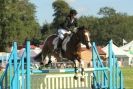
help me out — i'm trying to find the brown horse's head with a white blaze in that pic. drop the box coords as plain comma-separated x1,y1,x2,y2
76,27,91,49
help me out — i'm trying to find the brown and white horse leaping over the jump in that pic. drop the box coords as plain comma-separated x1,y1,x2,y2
35,27,91,81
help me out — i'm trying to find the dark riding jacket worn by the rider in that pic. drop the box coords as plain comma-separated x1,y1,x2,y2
62,15,78,30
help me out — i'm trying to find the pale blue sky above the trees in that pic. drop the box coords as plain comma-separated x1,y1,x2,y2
30,0,133,26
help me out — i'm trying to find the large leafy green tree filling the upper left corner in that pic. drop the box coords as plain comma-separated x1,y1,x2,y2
0,0,40,50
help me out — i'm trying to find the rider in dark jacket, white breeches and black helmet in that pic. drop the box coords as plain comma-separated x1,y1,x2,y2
56,9,78,52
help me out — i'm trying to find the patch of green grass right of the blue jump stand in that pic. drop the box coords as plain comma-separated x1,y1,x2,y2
121,67,133,89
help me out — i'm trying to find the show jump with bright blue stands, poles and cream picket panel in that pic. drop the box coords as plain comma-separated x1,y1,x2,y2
0,41,124,89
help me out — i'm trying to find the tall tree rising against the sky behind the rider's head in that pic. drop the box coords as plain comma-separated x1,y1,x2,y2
52,0,70,28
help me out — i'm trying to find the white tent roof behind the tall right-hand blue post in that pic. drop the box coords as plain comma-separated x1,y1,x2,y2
102,44,130,57
